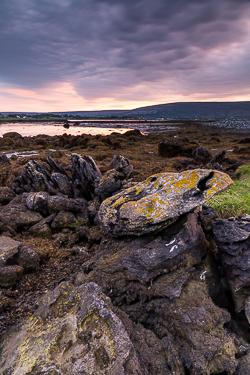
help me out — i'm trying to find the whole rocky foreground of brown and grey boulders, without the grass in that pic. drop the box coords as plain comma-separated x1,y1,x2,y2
0,128,250,375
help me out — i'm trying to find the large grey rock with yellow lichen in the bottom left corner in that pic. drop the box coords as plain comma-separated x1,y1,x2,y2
0,283,145,375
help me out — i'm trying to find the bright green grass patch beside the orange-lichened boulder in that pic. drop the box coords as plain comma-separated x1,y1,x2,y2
208,165,250,218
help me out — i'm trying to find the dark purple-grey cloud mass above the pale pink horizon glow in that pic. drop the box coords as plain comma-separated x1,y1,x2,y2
0,0,250,97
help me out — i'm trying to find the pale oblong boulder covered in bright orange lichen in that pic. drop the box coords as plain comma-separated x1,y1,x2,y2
99,169,233,236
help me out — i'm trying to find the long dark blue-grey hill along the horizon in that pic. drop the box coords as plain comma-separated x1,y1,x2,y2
2,102,250,120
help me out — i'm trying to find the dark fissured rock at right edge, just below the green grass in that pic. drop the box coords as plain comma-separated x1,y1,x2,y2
212,215,250,316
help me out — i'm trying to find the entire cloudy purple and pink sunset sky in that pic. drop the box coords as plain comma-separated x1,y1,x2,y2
0,0,250,112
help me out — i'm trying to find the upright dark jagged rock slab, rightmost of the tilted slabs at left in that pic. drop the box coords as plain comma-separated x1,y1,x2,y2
72,154,102,200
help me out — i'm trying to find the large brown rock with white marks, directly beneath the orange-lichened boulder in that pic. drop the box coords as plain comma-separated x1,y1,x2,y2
77,213,237,375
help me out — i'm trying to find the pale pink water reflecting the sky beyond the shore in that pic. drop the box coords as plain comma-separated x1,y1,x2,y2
0,123,135,137
